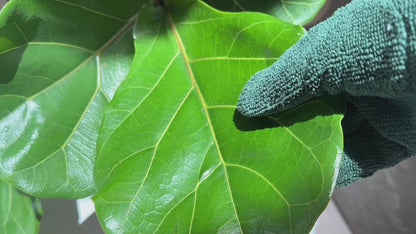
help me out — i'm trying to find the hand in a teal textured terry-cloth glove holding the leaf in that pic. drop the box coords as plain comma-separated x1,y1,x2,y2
237,0,416,187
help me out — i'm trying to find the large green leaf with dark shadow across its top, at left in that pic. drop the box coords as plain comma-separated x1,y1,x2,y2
0,0,141,198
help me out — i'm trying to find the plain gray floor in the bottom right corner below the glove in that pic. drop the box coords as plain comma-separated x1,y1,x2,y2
333,157,416,234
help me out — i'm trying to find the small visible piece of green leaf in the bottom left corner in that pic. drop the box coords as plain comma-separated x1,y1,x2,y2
0,180,40,234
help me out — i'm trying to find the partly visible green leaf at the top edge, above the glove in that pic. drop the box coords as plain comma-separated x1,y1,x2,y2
204,0,326,25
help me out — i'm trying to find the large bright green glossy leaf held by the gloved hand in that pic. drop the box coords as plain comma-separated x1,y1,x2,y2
93,2,342,233
